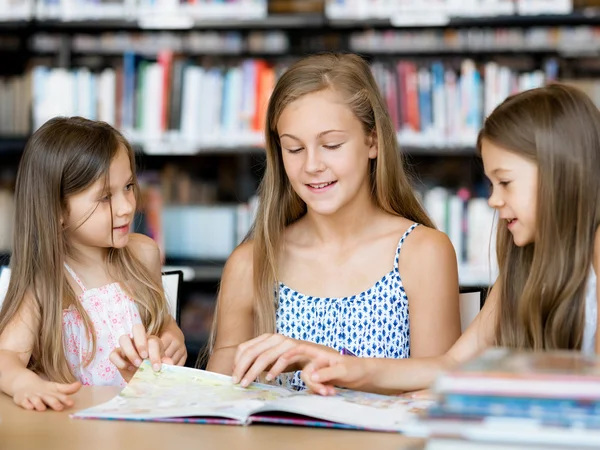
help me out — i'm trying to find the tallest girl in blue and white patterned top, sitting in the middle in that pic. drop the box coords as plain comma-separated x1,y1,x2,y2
208,54,460,389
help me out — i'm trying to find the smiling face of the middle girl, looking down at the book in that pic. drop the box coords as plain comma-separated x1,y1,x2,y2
277,89,377,215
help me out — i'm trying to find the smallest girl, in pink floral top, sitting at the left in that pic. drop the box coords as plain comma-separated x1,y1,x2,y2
0,117,186,411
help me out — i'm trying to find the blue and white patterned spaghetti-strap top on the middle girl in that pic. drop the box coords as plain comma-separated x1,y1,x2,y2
276,223,418,390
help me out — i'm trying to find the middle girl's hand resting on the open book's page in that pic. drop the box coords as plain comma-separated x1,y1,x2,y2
231,333,337,387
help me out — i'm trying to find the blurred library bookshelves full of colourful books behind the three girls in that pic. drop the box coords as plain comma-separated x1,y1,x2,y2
0,0,600,362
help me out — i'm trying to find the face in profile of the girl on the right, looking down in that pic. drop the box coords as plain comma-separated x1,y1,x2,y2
481,139,538,247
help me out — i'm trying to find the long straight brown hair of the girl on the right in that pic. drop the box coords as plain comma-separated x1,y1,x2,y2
477,84,600,349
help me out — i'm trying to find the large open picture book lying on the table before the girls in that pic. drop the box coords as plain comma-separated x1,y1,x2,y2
71,361,431,432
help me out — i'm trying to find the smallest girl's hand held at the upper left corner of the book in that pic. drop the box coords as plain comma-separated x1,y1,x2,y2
109,324,173,382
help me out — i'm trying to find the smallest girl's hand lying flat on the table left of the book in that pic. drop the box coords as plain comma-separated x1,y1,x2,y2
13,379,81,411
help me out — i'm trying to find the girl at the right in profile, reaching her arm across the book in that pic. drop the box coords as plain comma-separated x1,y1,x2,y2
271,84,600,394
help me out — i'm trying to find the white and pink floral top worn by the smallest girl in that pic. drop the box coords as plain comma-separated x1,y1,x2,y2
63,264,141,386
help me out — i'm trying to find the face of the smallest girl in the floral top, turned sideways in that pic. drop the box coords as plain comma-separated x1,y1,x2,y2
64,149,136,255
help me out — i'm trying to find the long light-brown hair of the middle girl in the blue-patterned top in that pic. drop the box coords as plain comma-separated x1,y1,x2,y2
208,54,434,358
